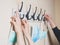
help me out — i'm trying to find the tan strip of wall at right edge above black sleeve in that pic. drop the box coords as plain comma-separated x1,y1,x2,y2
55,0,60,28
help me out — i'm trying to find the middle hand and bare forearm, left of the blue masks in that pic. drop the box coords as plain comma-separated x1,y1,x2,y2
22,20,34,45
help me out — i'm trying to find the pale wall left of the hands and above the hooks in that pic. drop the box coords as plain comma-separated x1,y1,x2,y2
0,0,54,45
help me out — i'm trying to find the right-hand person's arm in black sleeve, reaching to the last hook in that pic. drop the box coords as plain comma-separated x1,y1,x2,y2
44,15,60,42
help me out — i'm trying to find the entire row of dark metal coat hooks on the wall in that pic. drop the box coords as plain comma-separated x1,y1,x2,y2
19,2,46,21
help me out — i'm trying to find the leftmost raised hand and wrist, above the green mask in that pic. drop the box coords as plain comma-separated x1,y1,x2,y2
11,11,22,33
